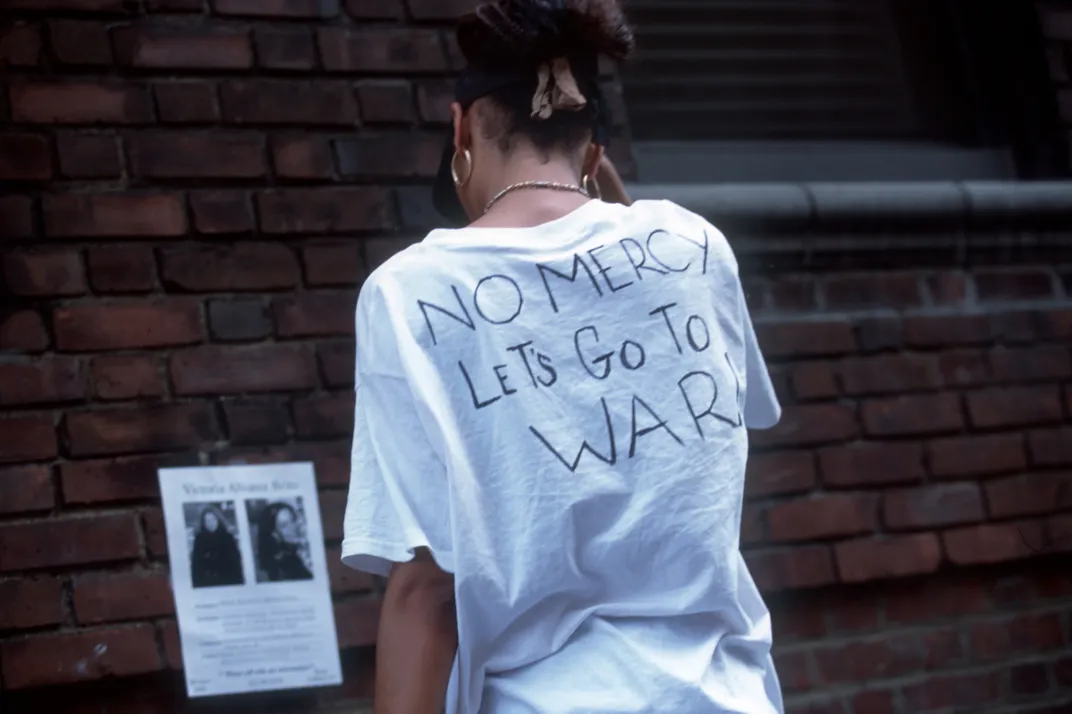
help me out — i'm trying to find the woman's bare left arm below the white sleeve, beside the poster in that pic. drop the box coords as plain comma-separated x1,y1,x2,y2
374,550,458,714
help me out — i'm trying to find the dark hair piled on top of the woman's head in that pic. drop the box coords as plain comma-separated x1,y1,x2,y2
458,0,636,65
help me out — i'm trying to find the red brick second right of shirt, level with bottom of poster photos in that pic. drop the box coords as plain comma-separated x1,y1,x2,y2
834,533,941,582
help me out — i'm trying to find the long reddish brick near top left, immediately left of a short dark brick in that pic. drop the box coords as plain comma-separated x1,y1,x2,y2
113,27,253,70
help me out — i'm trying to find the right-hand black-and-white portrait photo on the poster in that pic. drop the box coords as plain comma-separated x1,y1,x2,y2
245,496,313,582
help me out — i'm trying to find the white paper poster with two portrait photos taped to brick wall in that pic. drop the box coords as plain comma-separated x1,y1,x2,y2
159,463,342,697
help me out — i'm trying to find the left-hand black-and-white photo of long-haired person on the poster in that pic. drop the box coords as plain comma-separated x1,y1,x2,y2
182,501,245,587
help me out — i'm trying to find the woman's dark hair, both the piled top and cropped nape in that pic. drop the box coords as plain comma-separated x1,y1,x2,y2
458,0,636,157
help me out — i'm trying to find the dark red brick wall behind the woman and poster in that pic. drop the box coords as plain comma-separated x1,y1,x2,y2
0,0,1072,714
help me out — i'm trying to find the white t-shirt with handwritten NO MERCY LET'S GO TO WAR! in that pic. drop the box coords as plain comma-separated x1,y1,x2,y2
342,202,781,714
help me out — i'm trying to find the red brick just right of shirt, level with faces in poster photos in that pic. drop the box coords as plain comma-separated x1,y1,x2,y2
768,494,878,540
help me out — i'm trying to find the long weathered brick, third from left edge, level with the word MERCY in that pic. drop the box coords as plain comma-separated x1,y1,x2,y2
161,243,300,293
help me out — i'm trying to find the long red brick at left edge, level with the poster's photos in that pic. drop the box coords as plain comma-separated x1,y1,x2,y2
0,514,138,572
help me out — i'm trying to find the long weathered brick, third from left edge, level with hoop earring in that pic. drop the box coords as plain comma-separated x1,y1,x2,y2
128,132,268,179
